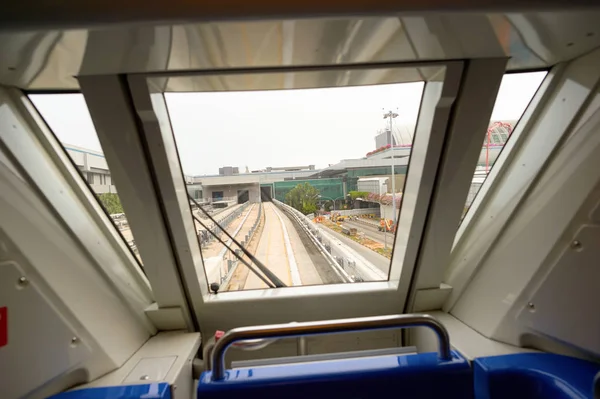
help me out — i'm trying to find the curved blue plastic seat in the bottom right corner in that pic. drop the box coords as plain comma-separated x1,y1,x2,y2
473,353,600,399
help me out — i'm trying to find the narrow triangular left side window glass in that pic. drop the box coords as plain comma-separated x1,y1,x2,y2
29,94,141,264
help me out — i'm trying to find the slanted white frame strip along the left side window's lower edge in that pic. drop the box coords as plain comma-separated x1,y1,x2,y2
0,88,156,333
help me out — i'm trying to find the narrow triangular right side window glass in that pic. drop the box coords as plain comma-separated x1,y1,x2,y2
462,72,547,218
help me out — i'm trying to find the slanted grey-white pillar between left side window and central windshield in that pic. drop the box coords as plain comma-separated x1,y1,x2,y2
79,75,194,330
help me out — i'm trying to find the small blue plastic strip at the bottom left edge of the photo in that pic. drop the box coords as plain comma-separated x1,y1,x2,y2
49,382,171,399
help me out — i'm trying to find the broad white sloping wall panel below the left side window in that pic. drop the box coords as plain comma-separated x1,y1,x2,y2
0,87,156,397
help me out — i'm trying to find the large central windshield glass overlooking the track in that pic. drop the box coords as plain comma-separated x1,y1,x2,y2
165,82,424,291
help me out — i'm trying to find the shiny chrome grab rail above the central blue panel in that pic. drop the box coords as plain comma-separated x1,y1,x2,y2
212,314,452,381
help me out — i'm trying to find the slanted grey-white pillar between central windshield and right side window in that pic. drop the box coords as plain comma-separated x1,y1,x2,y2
405,58,507,311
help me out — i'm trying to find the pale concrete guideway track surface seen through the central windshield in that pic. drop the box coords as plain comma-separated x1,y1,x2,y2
244,202,321,289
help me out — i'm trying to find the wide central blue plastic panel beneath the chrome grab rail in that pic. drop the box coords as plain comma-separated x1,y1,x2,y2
198,352,473,399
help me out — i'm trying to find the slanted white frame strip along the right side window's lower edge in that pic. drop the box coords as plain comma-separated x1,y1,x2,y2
443,62,584,312
